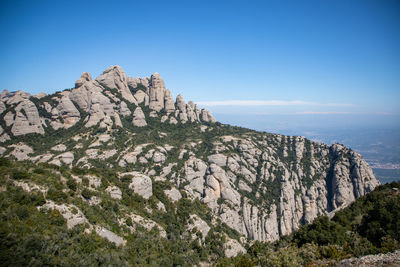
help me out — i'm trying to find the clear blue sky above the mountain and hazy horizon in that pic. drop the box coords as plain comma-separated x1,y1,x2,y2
0,0,400,133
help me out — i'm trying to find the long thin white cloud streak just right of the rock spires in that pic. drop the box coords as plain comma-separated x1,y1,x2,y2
197,100,353,107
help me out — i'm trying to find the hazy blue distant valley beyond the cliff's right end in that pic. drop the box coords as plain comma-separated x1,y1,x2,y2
214,113,400,183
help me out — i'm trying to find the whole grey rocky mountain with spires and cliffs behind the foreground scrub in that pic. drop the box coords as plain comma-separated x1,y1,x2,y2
0,66,379,242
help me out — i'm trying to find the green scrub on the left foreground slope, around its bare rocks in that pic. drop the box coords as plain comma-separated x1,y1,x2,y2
0,158,231,266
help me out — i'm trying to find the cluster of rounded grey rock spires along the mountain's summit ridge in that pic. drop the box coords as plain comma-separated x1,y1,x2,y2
0,66,215,142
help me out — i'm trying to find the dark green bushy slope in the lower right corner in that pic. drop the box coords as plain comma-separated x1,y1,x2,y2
217,182,400,266
